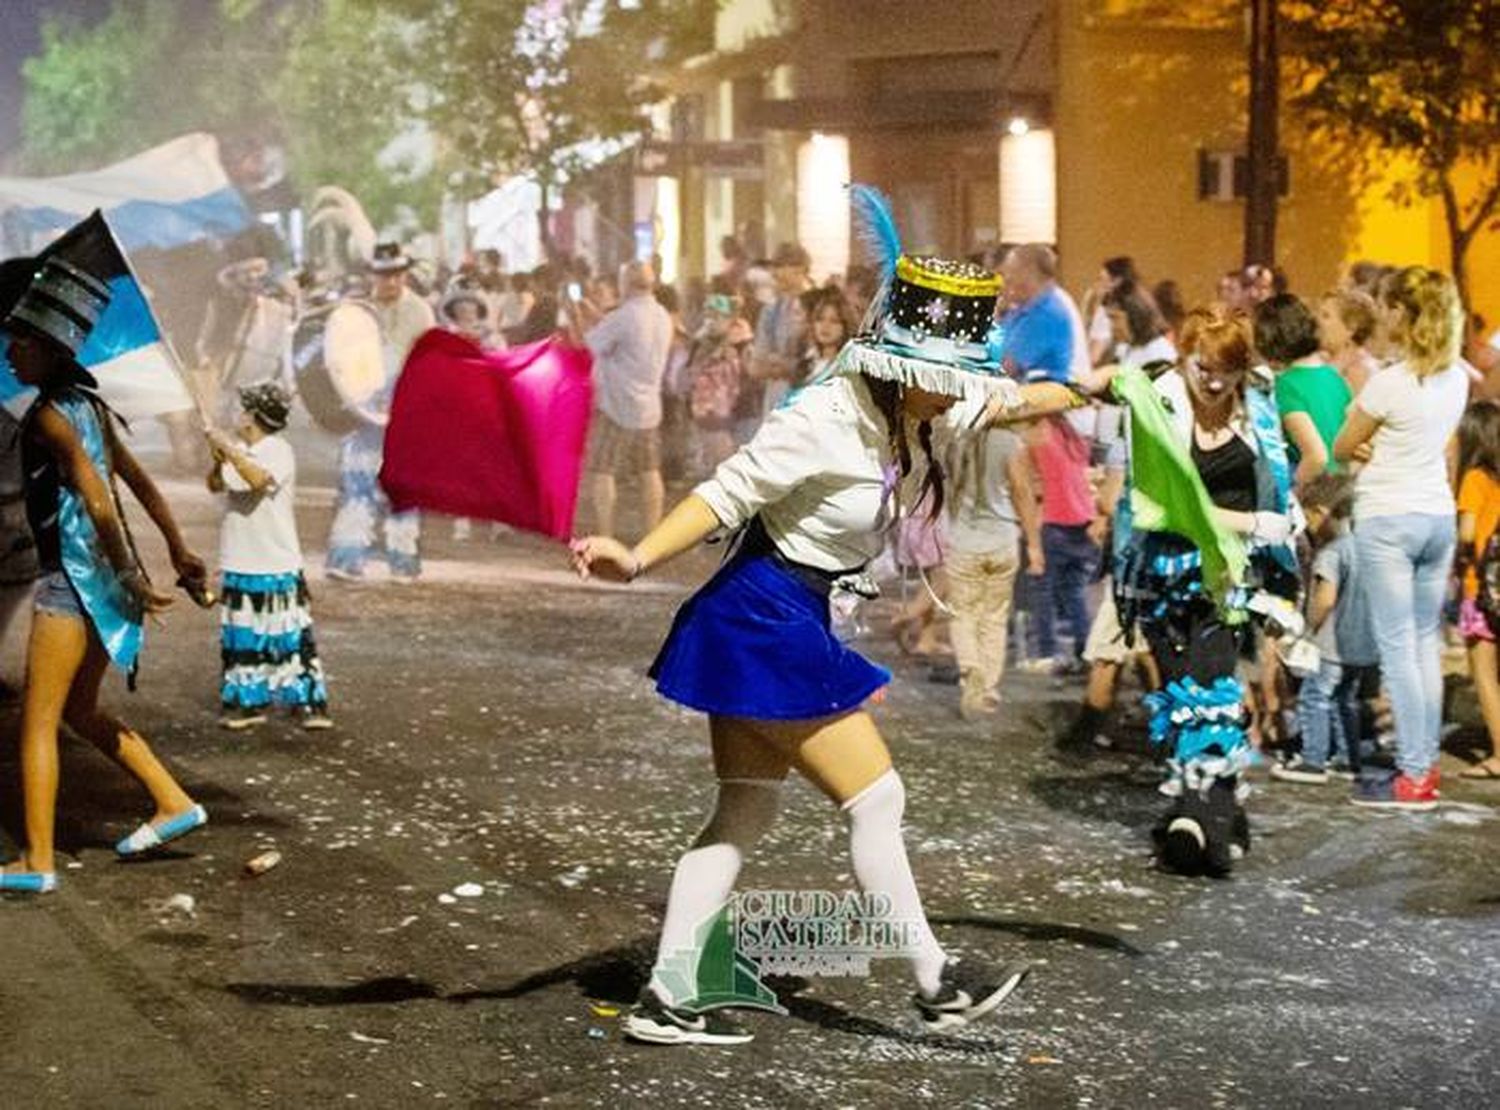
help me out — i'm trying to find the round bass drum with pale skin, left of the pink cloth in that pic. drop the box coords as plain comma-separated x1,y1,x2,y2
291,300,386,435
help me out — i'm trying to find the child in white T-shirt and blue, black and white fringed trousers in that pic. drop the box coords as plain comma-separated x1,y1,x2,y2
209,383,333,729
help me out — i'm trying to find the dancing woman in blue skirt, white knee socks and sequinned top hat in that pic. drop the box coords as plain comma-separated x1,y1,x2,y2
573,217,1077,1044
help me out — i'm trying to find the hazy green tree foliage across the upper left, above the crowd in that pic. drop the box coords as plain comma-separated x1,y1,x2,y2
23,0,716,241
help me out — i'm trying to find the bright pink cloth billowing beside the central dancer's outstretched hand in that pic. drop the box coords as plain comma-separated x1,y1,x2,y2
380,329,594,540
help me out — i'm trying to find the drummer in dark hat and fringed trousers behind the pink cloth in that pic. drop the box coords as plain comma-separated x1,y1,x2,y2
326,243,435,582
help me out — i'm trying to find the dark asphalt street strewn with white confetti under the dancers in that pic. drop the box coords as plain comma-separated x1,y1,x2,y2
0,471,1500,1109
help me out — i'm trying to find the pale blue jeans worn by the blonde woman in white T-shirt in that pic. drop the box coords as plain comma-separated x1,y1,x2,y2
1355,513,1457,779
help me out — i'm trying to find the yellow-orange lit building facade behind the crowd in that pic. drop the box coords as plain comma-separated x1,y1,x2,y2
638,0,1500,321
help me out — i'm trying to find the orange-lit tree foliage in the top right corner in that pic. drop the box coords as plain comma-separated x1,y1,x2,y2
1283,0,1500,303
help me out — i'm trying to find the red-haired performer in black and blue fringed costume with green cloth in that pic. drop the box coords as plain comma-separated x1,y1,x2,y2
1113,305,1301,876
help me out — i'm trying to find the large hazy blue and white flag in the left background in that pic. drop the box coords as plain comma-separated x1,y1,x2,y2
0,134,255,254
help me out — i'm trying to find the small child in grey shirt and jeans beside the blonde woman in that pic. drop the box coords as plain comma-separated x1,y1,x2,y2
1271,474,1376,783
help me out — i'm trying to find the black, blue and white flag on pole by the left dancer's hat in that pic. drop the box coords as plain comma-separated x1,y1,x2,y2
0,212,194,420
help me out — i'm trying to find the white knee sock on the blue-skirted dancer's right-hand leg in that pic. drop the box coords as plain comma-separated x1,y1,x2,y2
843,767,948,995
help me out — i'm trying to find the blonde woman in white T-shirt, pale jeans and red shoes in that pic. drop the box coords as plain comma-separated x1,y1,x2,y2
1334,266,1469,810
